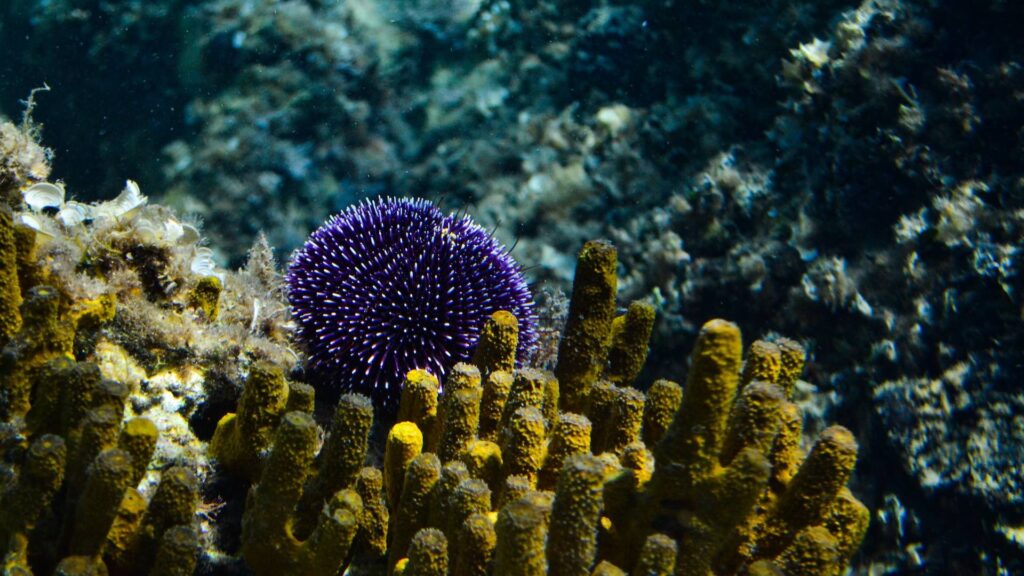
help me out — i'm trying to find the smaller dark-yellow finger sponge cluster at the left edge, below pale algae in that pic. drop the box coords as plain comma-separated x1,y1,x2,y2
0,266,200,575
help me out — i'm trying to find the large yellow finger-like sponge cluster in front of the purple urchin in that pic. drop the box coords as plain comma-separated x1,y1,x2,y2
222,237,868,576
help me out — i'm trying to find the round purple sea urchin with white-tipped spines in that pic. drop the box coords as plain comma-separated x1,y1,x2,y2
288,198,537,406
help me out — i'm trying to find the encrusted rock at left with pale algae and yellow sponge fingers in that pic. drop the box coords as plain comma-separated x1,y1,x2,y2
0,121,303,576
